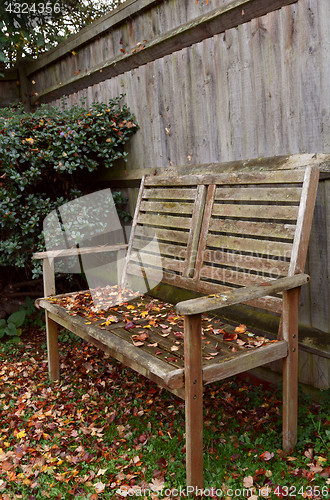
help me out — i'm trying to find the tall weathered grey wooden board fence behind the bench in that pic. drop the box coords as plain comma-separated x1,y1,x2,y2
0,0,330,388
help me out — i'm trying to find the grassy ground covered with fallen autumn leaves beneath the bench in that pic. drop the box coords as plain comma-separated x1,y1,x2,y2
0,328,330,500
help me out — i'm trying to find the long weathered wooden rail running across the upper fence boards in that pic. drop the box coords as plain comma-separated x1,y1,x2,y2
29,0,292,104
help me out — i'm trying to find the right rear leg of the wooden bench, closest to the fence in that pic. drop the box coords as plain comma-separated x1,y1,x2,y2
283,287,300,451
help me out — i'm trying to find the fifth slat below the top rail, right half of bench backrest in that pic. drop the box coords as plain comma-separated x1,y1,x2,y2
204,250,290,277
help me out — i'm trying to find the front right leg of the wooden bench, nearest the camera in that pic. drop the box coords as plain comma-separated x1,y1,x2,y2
184,314,203,491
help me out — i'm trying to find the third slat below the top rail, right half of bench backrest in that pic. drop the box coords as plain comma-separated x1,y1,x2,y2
210,219,296,240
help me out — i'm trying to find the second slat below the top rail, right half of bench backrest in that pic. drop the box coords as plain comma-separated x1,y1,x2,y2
213,203,299,221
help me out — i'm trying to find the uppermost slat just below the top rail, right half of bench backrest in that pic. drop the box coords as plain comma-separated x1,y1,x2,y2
215,187,301,203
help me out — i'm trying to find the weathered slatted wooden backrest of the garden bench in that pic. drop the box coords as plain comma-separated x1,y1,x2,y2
122,167,318,313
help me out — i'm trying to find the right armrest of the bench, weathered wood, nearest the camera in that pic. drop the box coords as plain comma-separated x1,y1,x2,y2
176,274,310,316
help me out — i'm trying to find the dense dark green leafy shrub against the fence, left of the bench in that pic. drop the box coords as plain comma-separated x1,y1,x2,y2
0,96,138,277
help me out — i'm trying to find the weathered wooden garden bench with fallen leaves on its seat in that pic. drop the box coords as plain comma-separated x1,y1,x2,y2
35,161,319,488
